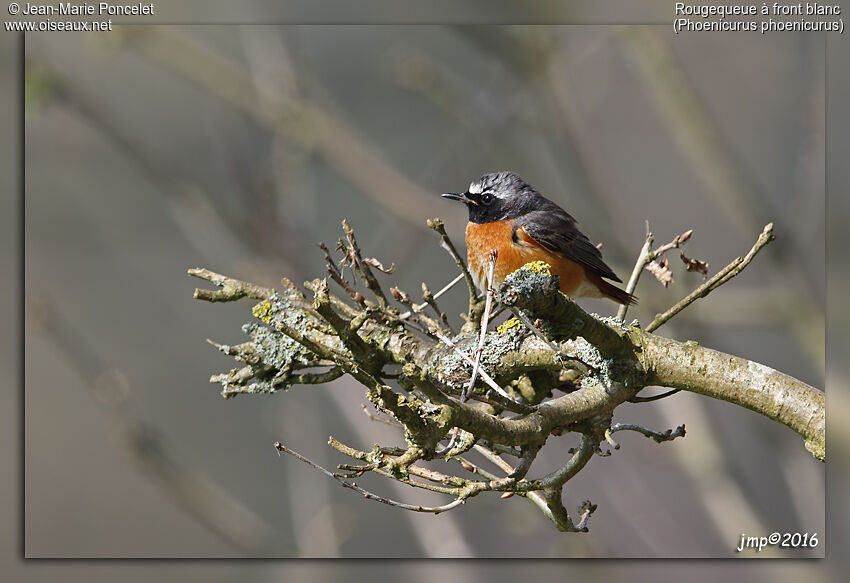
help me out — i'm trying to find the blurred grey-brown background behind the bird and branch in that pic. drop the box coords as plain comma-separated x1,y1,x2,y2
6,21,826,580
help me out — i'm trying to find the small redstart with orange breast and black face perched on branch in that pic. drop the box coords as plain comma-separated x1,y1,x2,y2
443,172,636,304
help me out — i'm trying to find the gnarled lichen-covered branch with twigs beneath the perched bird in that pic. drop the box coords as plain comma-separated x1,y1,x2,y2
189,223,825,532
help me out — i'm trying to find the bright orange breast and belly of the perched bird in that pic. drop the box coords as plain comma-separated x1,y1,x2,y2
466,220,601,297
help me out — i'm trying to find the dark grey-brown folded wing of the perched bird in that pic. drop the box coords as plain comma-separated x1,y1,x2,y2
513,209,622,282
